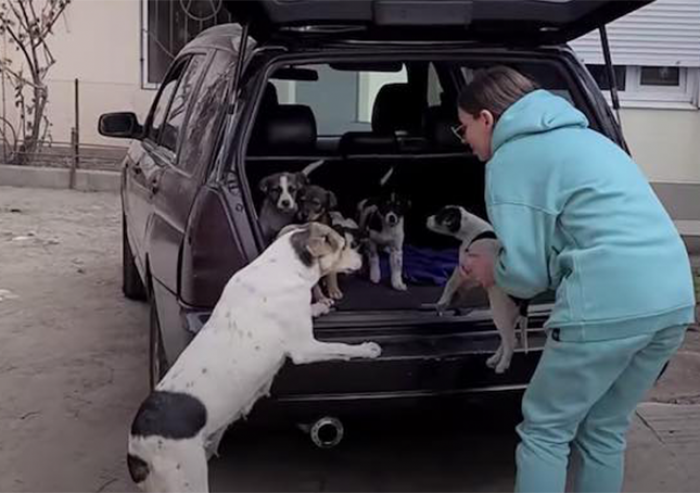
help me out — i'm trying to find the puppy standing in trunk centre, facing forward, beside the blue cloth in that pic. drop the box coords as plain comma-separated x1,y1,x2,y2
357,192,410,291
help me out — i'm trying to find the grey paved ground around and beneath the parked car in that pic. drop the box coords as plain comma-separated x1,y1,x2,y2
0,187,700,492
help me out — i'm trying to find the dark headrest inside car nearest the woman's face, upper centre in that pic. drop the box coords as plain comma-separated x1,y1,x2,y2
372,83,421,134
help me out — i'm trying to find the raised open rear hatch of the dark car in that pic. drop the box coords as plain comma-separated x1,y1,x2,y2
224,0,654,45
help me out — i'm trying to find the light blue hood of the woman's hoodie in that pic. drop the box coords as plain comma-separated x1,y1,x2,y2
492,89,588,152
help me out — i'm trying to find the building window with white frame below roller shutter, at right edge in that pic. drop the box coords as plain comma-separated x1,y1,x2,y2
587,65,700,108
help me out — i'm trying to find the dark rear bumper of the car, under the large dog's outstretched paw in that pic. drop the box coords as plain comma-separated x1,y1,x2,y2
179,306,546,422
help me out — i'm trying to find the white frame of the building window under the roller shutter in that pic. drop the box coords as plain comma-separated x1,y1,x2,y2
603,65,700,110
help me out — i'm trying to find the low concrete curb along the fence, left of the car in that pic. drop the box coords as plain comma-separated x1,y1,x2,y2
0,165,121,192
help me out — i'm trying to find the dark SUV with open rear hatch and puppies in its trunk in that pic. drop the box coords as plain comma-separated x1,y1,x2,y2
99,0,649,420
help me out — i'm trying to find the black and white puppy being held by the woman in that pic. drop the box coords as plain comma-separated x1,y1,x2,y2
426,205,528,373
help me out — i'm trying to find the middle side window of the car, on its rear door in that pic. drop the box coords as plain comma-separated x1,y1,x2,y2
160,54,206,152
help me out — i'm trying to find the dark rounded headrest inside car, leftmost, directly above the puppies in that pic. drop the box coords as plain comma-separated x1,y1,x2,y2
256,104,316,154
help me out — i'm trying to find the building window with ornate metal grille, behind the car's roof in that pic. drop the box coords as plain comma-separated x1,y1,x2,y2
141,0,231,88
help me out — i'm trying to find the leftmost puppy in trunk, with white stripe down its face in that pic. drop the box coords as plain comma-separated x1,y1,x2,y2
258,171,308,244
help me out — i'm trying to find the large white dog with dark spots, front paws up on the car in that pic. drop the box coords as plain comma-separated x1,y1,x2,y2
127,223,381,492
